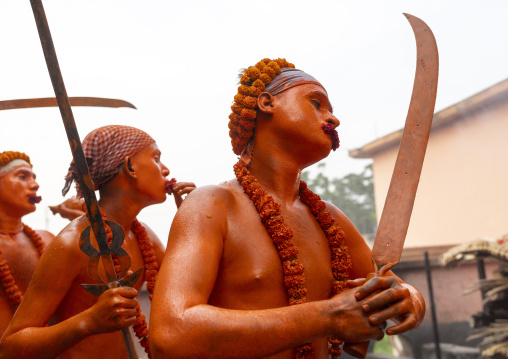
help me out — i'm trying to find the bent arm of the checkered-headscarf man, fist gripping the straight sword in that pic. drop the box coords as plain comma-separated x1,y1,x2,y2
0,224,137,358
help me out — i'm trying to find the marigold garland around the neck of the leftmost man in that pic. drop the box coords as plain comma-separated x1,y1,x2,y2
0,226,46,310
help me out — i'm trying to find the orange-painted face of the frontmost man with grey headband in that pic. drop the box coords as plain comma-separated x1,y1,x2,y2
266,84,340,165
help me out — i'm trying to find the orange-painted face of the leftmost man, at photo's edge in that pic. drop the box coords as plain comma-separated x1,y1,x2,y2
0,164,39,217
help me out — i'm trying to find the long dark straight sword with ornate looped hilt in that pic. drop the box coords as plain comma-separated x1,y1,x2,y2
30,0,142,359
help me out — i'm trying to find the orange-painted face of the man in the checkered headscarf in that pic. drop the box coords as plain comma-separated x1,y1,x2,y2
132,143,169,204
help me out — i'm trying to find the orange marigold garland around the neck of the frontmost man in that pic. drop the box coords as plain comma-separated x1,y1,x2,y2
234,160,351,359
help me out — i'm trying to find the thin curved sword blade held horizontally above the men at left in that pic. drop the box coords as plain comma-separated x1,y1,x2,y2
0,97,136,110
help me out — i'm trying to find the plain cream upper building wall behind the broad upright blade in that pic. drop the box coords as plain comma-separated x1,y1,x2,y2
373,102,508,247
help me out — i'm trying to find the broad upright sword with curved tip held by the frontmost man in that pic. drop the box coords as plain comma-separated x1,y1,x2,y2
344,14,439,358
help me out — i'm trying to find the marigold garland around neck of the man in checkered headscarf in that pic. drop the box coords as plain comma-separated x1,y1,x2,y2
83,205,159,358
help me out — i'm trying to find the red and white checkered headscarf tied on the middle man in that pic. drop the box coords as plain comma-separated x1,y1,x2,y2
62,125,155,197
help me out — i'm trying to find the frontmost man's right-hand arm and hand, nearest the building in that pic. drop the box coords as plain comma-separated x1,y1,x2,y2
327,203,425,335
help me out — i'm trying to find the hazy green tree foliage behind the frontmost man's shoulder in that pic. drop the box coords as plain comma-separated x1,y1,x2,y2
302,163,377,234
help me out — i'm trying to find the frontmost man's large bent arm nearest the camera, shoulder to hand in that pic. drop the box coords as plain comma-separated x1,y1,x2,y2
150,186,382,358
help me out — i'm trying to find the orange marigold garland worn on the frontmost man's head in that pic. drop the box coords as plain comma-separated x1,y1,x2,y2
228,59,295,155
